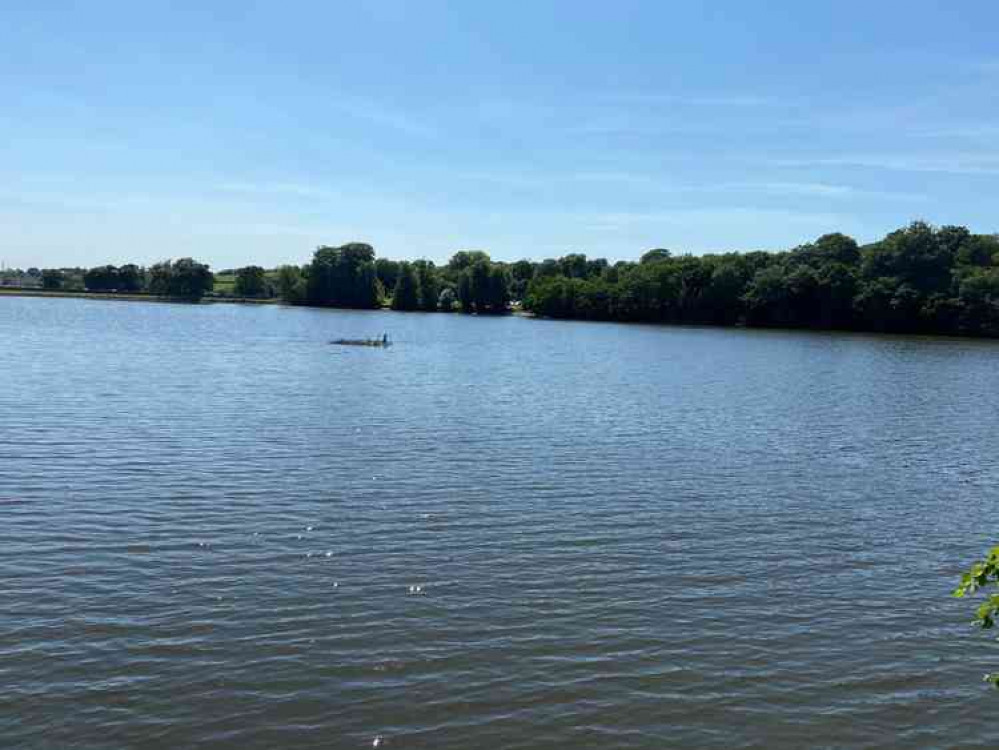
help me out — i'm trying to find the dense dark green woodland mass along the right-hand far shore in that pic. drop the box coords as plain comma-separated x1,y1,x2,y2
518,222,999,337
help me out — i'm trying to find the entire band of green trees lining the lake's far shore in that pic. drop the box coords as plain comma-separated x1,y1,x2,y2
7,222,999,337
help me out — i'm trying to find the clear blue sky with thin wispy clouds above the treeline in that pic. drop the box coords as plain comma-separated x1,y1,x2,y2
0,0,999,269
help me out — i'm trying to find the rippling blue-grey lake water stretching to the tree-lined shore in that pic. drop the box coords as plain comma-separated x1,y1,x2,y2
0,298,999,750
